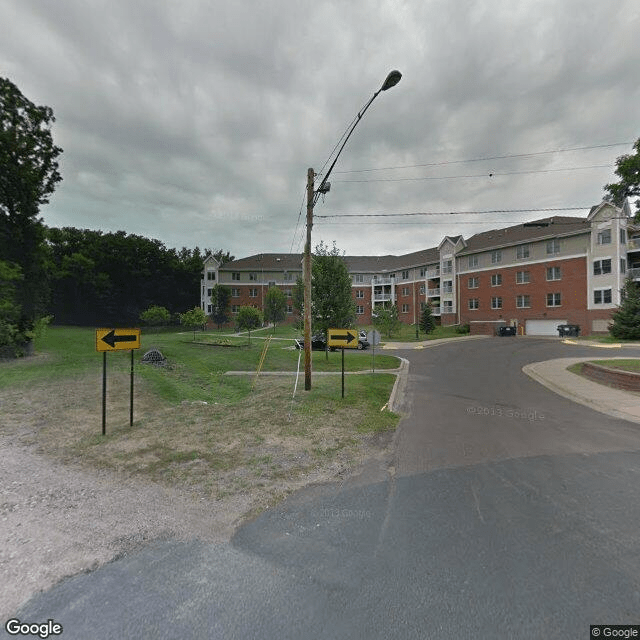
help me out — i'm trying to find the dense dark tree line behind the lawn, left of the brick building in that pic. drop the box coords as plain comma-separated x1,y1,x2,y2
44,227,233,325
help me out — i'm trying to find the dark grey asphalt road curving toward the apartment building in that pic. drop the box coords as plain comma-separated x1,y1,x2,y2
6,338,640,640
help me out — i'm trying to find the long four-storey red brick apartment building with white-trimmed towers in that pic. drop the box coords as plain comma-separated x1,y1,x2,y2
201,201,640,335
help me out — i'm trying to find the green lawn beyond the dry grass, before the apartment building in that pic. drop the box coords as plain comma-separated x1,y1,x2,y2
0,327,399,402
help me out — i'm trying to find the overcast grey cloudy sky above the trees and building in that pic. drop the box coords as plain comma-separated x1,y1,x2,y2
0,0,640,257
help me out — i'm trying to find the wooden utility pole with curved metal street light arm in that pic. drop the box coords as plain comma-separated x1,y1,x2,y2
303,69,402,391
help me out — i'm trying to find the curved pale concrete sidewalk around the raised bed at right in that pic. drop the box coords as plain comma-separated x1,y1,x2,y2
522,358,640,424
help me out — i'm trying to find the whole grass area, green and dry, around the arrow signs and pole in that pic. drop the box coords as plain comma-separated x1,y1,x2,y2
0,327,399,510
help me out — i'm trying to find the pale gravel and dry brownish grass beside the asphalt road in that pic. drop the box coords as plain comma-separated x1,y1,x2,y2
0,374,393,619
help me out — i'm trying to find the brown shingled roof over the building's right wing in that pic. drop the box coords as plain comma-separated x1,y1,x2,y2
458,216,591,255
